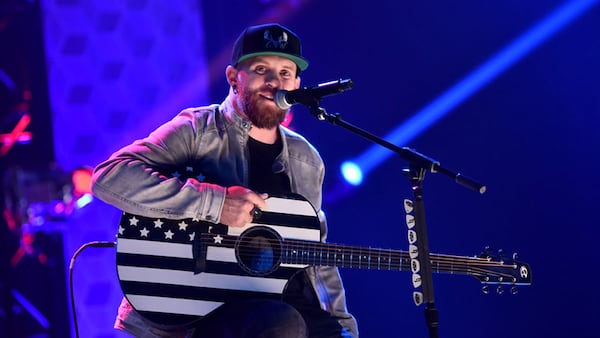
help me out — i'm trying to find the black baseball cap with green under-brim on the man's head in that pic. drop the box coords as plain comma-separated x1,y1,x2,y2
231,23,308,70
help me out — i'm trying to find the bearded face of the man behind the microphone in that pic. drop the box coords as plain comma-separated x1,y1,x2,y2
236,55,300,129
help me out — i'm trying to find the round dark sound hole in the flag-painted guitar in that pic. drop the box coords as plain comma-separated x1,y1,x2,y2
235,226,281,276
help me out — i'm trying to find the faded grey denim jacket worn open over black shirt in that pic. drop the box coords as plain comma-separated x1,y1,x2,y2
92,97,358,337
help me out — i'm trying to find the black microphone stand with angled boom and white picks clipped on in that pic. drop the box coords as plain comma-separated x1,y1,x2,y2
305,103,486,338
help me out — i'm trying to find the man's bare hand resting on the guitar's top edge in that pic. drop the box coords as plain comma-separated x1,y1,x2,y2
221,186,268,227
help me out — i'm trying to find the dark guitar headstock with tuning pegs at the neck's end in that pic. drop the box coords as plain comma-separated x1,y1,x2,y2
469,249,531,293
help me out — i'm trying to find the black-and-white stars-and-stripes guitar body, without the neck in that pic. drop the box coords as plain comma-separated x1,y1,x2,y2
117,196,321,325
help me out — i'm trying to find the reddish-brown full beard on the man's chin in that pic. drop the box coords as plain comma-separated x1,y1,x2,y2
243,92,287,129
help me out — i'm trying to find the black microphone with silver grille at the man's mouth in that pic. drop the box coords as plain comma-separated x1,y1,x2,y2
275,79,354,109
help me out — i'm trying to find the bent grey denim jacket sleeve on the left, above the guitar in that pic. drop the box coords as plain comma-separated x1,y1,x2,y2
92,109,225,223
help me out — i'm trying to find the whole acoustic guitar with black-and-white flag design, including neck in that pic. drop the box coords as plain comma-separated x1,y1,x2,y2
117,195,531,325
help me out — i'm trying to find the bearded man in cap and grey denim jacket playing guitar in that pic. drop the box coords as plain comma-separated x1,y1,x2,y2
92,24,358,338
